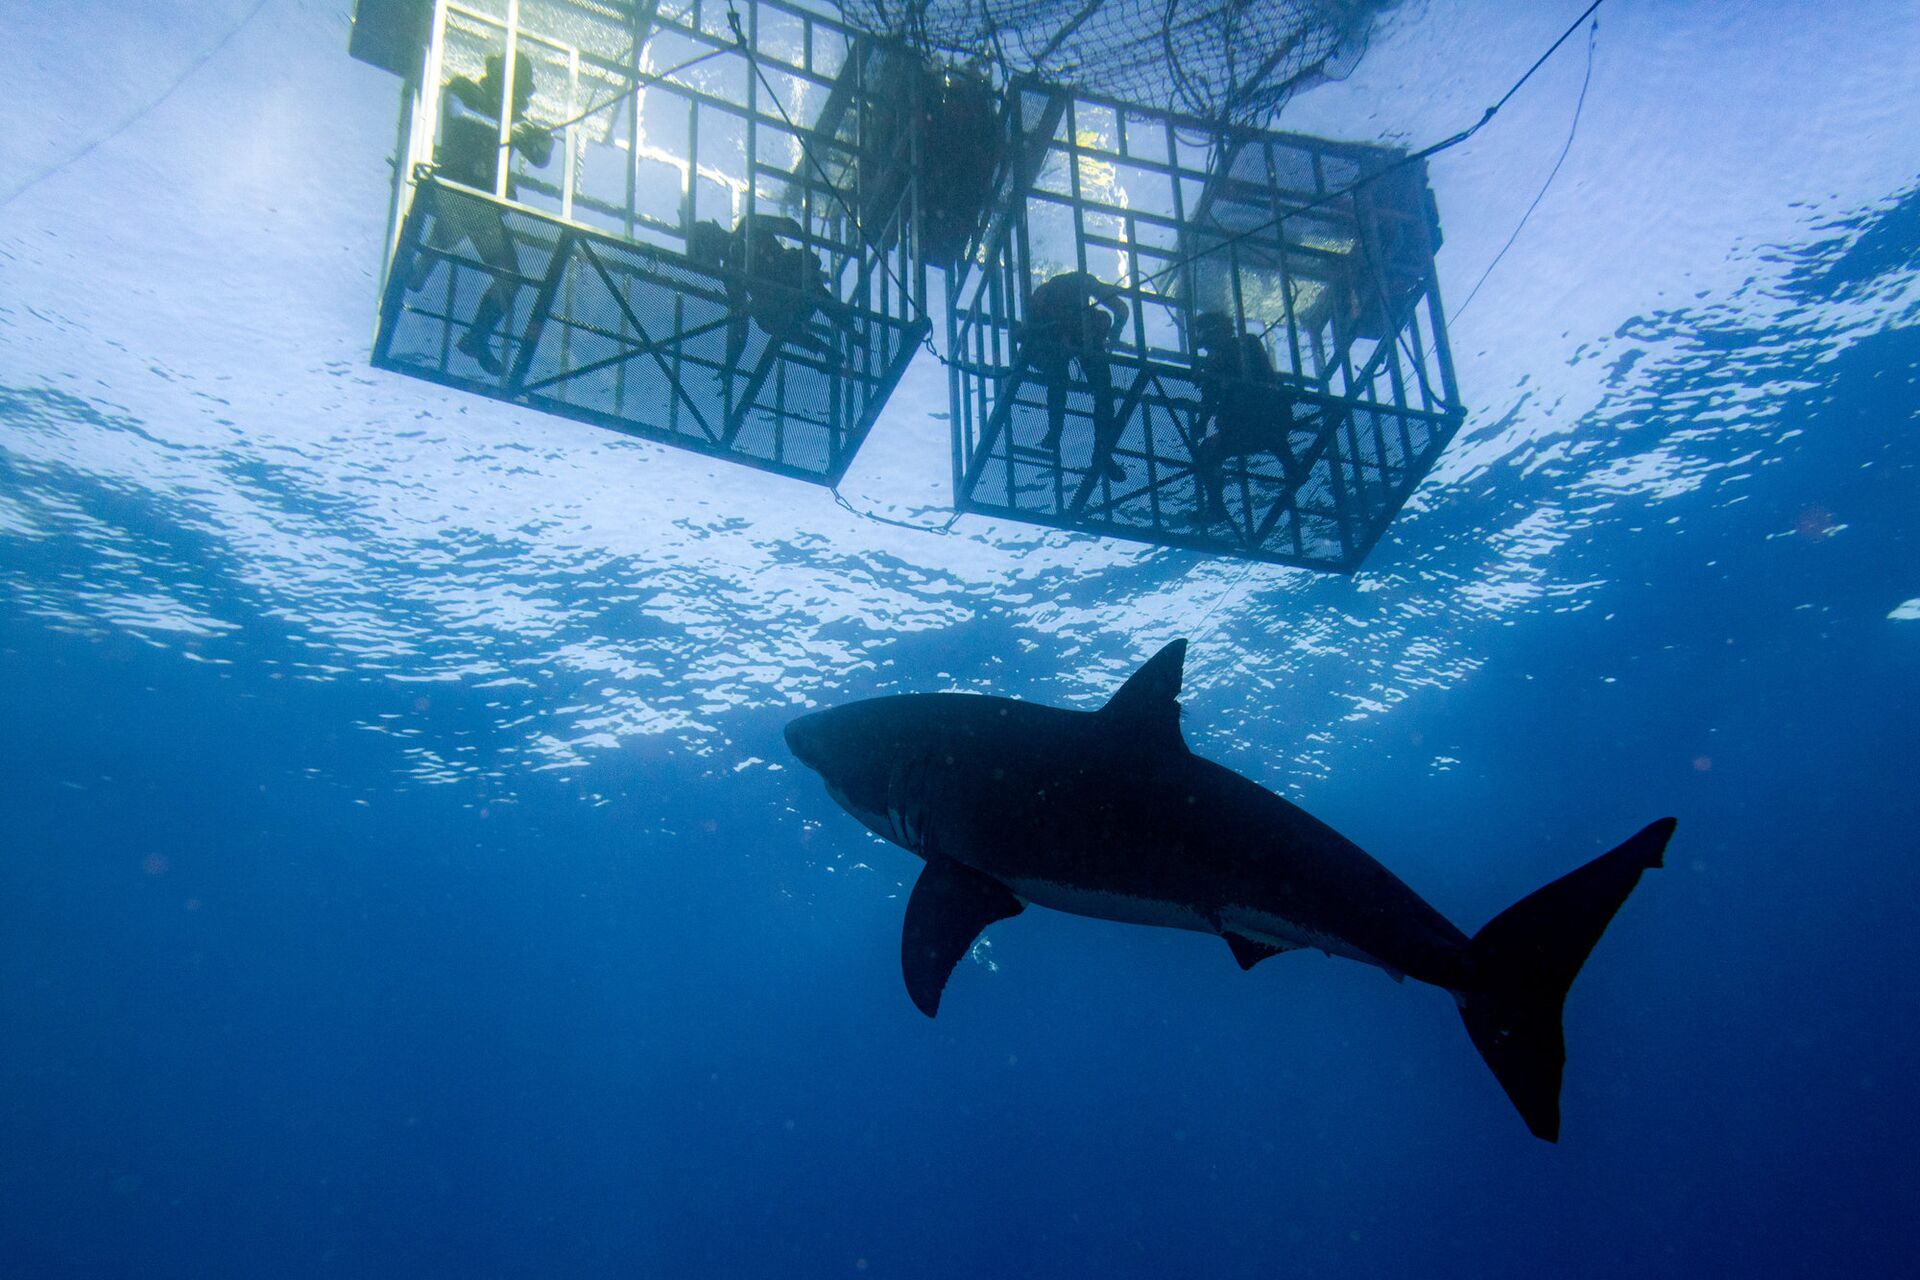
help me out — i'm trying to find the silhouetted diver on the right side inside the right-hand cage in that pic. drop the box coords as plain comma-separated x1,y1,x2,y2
1192,311,1320,526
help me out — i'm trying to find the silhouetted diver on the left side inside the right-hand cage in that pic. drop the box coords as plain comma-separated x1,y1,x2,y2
1014,271,1127,480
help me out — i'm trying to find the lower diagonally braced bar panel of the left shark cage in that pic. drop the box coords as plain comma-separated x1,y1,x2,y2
376,184,922,482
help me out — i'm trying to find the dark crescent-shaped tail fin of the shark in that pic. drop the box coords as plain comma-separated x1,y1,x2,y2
1459,818,1674,1142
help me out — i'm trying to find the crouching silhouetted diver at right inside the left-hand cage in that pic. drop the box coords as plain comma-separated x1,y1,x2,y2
687,213,860,378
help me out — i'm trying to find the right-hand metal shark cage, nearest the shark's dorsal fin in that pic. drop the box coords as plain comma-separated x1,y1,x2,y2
947,81,1463,572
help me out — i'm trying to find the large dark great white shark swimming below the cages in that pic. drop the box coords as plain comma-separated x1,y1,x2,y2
785,641,1674,1142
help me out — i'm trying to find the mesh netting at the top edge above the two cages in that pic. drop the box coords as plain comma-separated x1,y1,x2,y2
839,0,1390,123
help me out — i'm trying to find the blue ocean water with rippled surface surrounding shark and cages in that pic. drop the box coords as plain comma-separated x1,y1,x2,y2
0,0,1920,1278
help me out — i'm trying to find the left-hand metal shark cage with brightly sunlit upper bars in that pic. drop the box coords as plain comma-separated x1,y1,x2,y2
351,0,929,484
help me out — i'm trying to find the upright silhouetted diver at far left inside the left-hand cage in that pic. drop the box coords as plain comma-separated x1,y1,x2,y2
407,54,553,376
